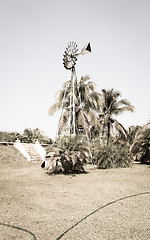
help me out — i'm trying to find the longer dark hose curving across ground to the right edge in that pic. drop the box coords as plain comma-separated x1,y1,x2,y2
56,192,150,240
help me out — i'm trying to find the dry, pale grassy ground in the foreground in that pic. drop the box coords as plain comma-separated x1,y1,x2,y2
0,146,150,240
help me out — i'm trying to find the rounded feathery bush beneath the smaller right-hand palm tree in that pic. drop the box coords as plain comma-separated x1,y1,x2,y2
95,144,133,169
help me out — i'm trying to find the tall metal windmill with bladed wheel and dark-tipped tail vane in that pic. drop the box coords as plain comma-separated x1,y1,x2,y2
62,42,91,136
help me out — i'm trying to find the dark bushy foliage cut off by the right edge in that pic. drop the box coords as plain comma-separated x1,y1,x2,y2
131,124,150,164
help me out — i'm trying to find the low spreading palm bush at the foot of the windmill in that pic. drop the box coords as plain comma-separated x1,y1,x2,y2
42,136,90,173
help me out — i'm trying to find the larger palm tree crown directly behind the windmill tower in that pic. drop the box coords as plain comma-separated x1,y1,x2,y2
49,76,101,138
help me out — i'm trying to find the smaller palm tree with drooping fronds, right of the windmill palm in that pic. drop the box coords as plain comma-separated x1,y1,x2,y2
99,88,134,145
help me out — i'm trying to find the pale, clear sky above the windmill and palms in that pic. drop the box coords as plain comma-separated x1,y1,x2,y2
0,0,150,139
